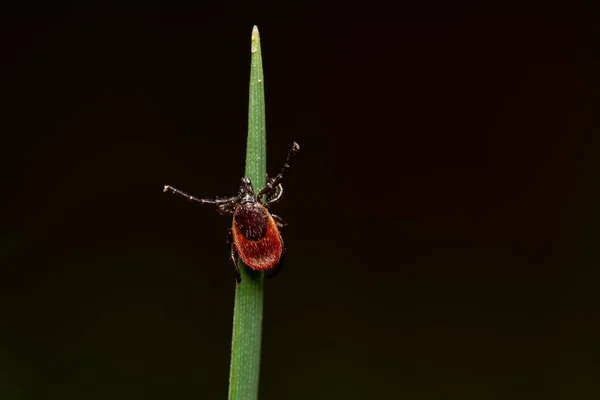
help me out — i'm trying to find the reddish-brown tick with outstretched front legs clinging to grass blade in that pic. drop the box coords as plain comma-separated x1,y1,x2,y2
164,142,300,284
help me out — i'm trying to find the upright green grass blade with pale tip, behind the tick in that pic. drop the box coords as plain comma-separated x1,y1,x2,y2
229,26,267,400
